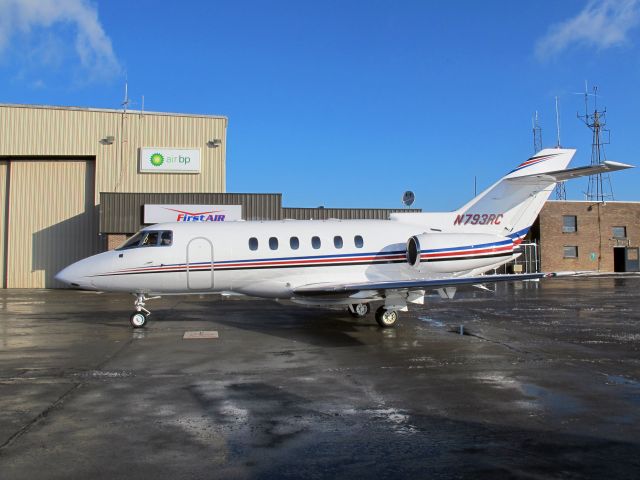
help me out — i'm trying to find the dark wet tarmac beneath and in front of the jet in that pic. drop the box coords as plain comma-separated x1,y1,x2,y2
0,278,640,479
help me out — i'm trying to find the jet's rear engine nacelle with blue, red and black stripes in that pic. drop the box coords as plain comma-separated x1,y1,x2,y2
407,233,515,273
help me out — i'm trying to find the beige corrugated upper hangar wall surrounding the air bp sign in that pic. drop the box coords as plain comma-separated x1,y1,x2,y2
0,105,227,204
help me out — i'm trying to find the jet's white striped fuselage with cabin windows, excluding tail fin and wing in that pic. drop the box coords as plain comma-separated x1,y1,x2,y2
57,220,524,298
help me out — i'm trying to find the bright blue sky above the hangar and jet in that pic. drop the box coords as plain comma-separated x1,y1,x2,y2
0,0,640,211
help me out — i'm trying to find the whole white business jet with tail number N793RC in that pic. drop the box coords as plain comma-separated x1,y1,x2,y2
56,148,631,328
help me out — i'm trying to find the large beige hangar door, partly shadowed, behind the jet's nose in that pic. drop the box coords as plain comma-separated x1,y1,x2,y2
0,159,98,288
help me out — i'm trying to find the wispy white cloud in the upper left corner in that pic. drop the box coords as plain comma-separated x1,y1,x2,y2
0,0,122,80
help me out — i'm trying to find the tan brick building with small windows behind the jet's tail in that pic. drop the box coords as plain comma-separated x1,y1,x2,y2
531,201,640,272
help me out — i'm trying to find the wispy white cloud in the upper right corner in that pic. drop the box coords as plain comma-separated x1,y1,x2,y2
535,0,640,60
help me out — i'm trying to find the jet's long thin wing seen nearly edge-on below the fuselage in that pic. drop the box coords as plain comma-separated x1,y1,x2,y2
294,272,564,296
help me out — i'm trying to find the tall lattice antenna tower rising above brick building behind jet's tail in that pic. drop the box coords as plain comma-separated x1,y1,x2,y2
578,82,613,202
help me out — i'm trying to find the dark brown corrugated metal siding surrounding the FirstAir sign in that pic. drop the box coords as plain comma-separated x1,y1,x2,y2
100,192,282,233
